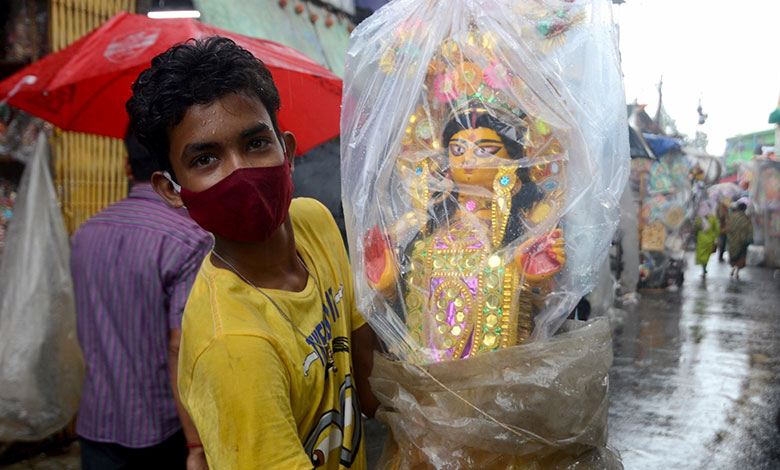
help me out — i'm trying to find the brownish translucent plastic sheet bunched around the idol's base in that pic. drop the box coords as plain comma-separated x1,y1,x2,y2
371,317,623,470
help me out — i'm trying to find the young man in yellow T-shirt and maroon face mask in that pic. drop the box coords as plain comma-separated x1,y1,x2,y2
127,37,377,469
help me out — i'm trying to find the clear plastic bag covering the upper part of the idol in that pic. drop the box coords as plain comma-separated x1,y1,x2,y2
341,0,629,364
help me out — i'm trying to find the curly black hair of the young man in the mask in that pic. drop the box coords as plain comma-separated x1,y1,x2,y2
126,36,280,177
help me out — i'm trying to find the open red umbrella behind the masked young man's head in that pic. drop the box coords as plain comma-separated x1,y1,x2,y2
0,13,342,154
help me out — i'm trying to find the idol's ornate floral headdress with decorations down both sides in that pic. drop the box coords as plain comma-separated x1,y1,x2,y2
380,16,576,224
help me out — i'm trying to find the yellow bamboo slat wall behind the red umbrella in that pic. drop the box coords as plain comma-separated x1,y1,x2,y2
49,0,135,235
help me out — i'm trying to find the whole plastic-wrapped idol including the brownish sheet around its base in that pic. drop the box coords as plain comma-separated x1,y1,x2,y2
341,0,629,468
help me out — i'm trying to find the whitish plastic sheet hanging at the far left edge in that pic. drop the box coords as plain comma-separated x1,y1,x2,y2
0,133,84,441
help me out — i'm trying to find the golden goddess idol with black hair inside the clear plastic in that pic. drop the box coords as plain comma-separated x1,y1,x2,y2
363,30,568,362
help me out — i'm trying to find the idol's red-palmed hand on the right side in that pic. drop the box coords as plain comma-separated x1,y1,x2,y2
515,228,566,285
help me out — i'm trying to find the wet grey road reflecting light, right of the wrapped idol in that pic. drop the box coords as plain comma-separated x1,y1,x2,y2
609,257,780,470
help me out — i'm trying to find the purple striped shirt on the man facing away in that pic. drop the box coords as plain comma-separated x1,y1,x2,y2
71,184,212,448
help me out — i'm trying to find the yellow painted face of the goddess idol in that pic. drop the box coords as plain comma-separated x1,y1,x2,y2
448,127,510,190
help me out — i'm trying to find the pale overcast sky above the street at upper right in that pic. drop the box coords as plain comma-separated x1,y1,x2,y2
613,0,780,155
